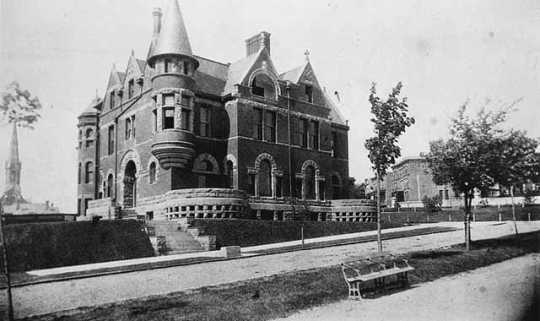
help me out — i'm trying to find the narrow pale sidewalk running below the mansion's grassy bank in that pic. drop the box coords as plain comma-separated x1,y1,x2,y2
11,222,460,288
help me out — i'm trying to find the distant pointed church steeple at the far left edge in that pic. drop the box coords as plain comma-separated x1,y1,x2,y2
2,122,25,205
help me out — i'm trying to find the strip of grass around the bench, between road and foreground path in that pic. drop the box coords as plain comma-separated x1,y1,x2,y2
21,232,540,321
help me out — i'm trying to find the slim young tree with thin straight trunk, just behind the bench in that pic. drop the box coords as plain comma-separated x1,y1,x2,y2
365,82,414,252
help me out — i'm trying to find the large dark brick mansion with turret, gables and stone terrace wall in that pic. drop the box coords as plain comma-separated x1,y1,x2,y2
78,0,374,221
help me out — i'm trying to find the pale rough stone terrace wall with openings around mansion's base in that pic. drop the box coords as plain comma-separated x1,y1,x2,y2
89,188,377,222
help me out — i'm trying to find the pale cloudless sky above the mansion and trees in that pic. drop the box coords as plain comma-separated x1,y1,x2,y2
0,0,540,212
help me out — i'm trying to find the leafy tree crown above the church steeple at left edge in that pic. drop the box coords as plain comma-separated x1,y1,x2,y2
0,81,41,129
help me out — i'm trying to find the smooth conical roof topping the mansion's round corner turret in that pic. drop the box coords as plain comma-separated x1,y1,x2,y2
148,0,193,61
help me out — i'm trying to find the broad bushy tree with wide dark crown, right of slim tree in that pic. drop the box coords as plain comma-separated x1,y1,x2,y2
427,102,538,250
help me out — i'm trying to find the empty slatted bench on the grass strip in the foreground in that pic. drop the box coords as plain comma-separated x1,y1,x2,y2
341,256,414,300
